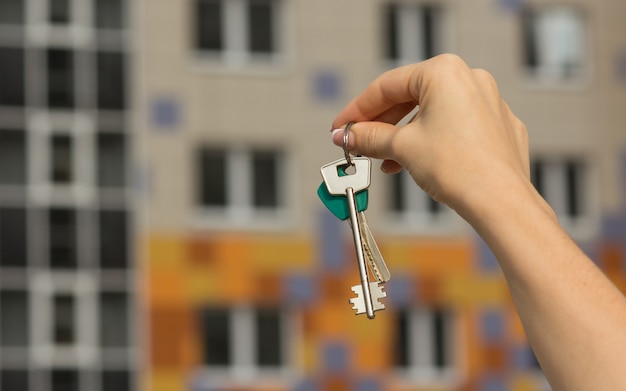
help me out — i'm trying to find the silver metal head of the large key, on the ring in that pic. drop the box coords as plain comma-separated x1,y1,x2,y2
320,157,372,195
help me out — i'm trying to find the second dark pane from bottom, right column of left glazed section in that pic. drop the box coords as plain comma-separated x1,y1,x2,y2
100,292,130,348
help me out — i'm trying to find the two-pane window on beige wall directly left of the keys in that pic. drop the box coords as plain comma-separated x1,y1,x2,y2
198,148,285,217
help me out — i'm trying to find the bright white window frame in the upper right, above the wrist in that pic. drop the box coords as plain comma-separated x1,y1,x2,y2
524,4,591,87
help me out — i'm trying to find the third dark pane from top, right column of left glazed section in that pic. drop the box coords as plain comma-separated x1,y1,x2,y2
97,133,126,188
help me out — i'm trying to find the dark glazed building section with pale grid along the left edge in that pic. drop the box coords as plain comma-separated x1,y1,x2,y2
0,0,136,391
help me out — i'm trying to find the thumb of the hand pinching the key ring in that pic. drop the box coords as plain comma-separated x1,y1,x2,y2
332,121,398,160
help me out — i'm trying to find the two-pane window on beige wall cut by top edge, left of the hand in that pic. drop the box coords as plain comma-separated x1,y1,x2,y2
194,0,282,62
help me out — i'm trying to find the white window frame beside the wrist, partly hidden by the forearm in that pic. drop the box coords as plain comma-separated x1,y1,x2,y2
532,155,600,240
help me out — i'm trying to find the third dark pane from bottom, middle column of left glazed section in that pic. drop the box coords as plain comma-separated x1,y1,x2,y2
49,209,77,268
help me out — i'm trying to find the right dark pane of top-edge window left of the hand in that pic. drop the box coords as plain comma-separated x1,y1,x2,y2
248,0,275,53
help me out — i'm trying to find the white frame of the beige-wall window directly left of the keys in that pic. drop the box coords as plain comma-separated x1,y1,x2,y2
194,147,295,230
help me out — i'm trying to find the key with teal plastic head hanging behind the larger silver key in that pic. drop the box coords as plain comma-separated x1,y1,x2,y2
317,167,391,283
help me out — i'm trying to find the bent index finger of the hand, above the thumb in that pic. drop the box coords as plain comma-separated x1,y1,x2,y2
332,63,423,129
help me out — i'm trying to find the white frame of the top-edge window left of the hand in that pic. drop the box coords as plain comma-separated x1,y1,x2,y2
190,0,294,75
